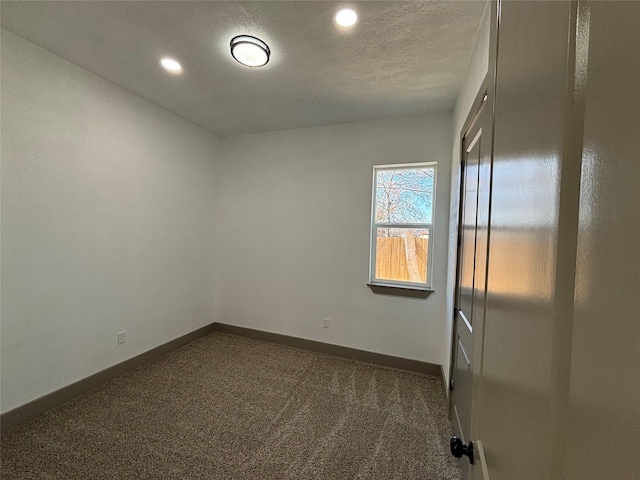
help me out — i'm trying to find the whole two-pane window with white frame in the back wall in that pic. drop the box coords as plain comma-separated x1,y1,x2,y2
369,163,436,290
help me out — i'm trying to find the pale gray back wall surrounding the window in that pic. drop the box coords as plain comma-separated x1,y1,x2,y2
216,113,451,364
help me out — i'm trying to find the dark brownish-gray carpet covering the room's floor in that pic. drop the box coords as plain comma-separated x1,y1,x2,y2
1,333,460,480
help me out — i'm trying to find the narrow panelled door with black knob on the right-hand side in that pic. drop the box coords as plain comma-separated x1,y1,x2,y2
450,86,492,479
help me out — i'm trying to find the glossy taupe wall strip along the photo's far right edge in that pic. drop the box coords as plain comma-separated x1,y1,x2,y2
563,2,640,479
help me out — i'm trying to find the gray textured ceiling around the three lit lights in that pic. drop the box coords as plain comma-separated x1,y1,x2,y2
1,0,486,136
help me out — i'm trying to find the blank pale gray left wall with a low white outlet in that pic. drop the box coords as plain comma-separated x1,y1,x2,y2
1,30,219,412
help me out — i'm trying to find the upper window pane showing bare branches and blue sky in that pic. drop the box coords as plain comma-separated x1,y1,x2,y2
375,167,435,223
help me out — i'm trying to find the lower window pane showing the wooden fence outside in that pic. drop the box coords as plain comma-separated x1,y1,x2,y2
375,228,429,283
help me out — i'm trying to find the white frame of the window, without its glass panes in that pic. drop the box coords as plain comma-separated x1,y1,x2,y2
369,162,438,291
